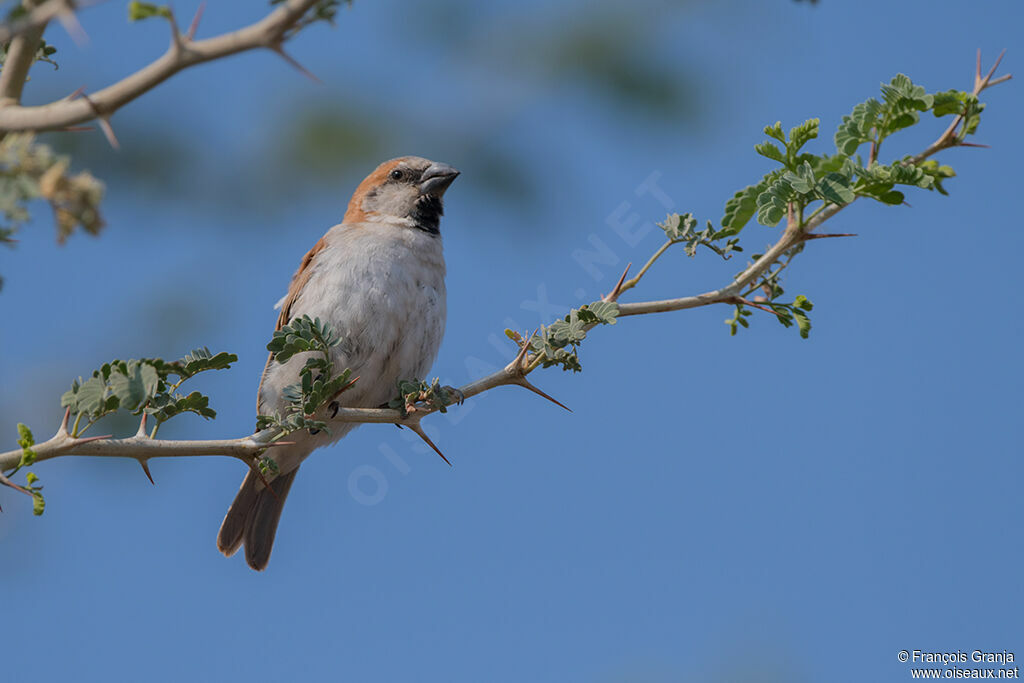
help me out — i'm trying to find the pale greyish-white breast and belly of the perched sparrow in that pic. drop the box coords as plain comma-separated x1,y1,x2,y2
259,223,446,471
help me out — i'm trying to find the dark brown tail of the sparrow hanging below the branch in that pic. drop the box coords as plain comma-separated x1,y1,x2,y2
217,468,299,571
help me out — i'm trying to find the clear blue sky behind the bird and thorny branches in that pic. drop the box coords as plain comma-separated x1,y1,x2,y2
0,0,1024,683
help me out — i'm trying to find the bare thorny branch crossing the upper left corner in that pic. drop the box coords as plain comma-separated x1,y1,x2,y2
0,0,317,131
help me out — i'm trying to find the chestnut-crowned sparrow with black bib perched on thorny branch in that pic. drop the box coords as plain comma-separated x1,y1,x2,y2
217,157,459,570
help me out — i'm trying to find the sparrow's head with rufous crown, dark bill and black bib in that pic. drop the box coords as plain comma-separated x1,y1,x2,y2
344,157,459,234
